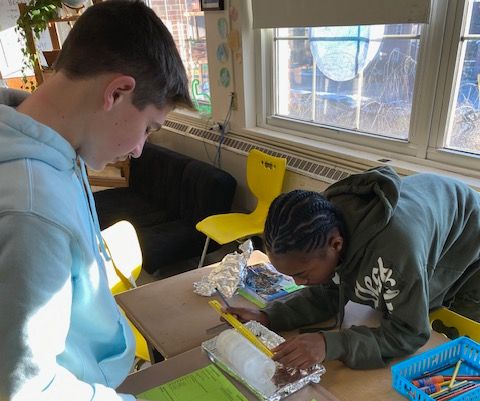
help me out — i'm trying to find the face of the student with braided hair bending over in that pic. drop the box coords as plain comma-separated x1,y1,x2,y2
268,231,343,285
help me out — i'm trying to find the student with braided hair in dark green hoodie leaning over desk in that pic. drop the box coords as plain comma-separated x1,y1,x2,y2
228,167,480,369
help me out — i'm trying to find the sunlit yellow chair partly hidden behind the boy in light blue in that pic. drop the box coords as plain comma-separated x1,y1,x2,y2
102,220,150,361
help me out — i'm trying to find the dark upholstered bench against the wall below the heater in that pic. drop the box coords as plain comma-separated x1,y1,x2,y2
94,143,236,274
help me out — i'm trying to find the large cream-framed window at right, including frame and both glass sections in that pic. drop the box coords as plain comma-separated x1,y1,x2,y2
260,0,480,170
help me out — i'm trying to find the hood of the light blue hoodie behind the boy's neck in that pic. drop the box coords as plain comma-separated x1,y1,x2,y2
0,88,76,170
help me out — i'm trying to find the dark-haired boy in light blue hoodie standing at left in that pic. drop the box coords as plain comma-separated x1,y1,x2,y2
0,1,192,401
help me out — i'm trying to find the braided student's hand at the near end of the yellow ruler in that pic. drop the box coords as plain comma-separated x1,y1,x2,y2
272,333,326,369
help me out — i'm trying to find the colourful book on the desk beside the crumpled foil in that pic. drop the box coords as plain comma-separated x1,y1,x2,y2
237,263,304,308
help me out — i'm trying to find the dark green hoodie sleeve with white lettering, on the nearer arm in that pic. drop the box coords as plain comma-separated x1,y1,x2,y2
324,258,431,369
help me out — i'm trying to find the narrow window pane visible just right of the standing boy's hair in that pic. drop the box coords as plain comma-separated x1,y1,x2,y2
150,0,212,114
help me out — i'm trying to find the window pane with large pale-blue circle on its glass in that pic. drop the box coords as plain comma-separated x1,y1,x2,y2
276,24,420,139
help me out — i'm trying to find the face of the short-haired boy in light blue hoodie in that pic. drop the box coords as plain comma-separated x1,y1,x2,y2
81,84,172,170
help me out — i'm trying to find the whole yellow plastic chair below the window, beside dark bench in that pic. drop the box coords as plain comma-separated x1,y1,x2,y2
196,149,287,267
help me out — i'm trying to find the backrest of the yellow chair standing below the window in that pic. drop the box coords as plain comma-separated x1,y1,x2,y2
247,149,287,209
